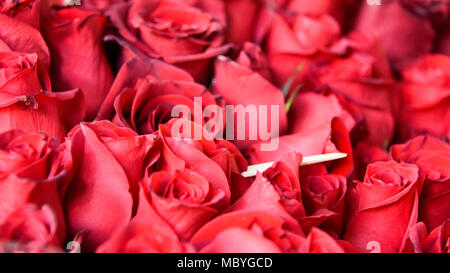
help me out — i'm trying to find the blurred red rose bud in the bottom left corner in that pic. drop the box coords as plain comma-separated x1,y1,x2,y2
0,204,61,253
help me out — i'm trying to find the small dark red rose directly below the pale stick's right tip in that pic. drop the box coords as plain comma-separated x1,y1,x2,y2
300,171,347,237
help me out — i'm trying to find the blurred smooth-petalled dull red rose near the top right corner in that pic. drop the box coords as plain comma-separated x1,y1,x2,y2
356,0,435,68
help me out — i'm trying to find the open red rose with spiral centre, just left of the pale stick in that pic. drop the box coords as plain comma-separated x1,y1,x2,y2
132,120,247,240
